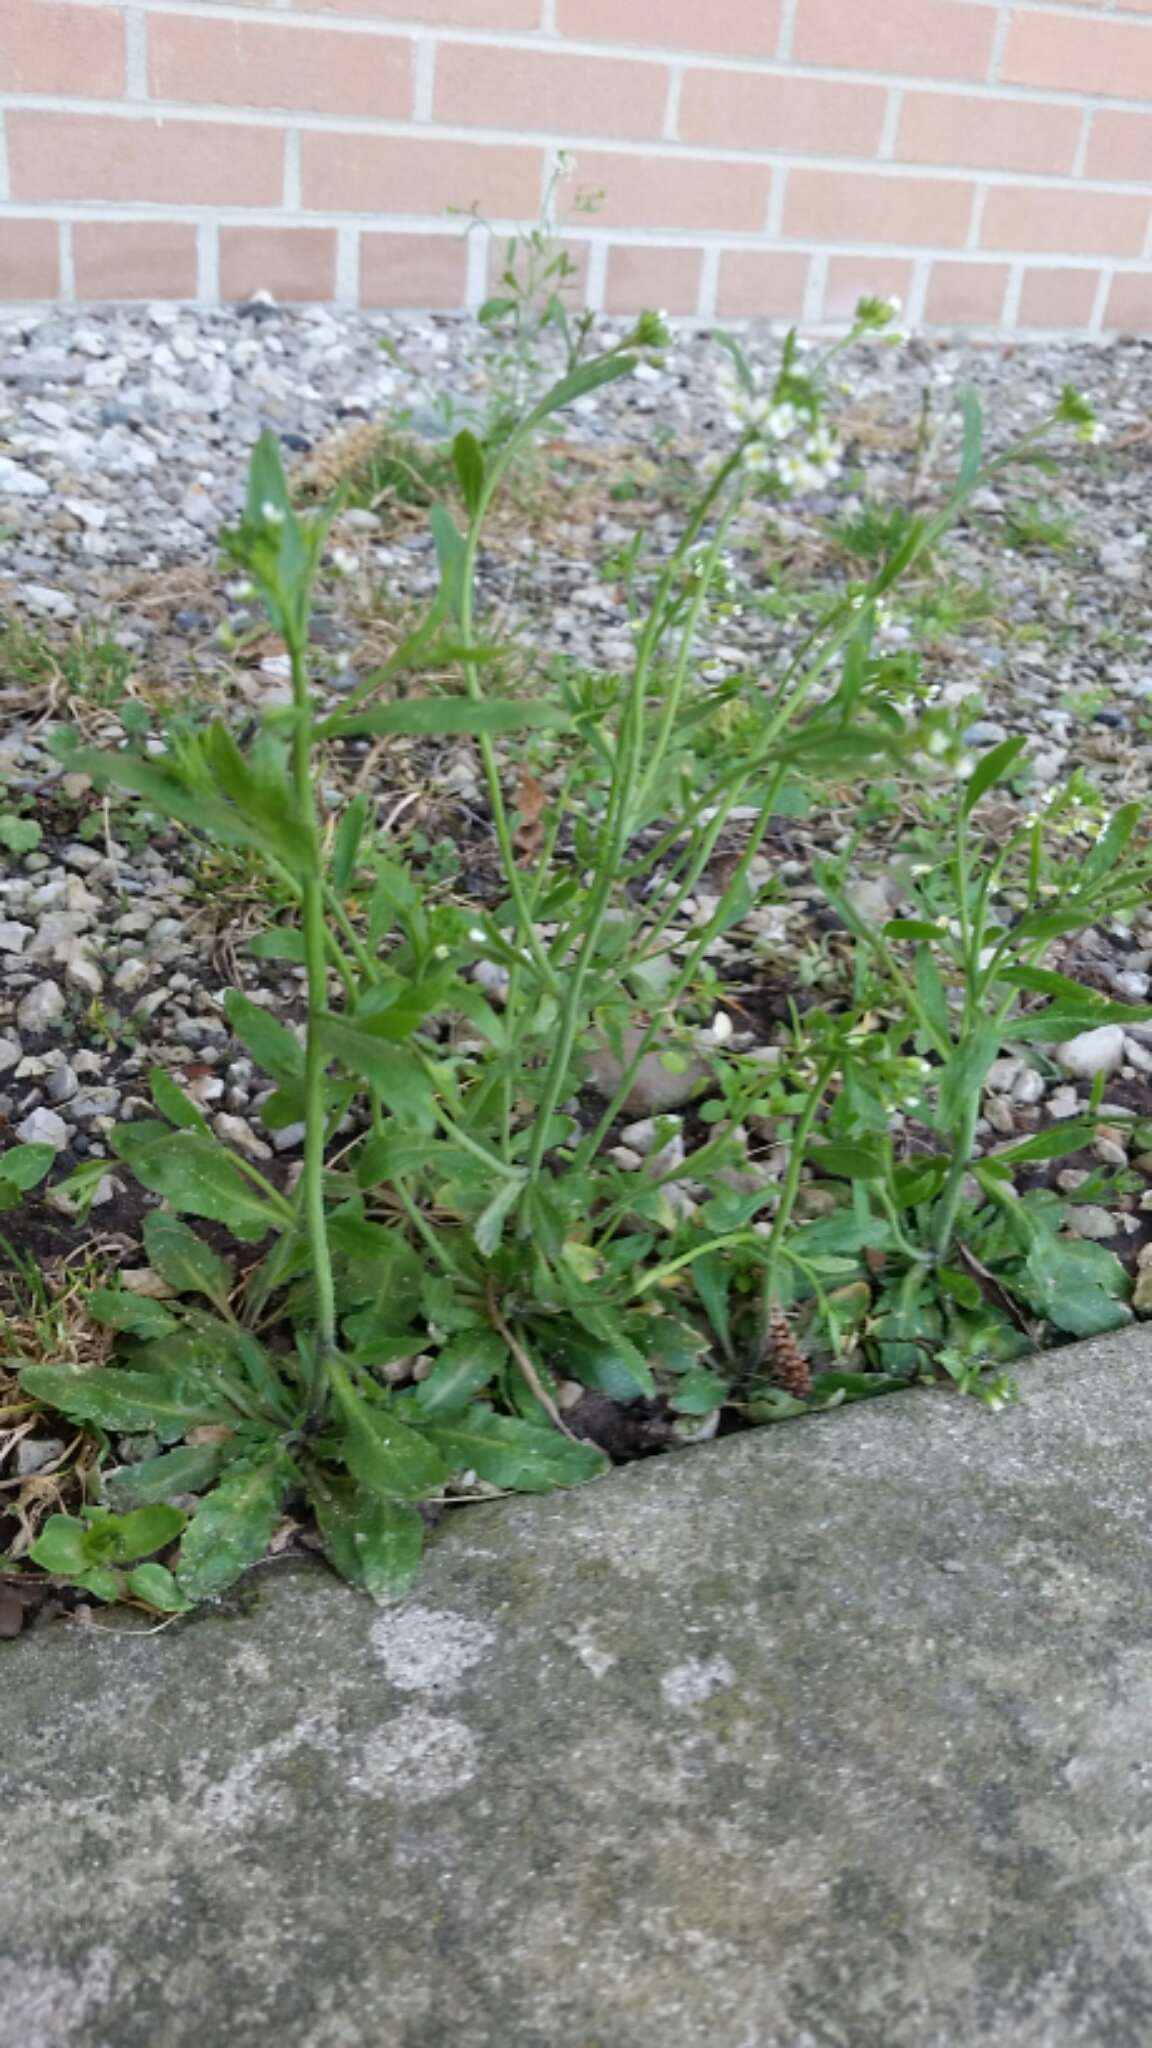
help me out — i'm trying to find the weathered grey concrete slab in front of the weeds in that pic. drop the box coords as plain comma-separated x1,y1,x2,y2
0,1333,1152,2048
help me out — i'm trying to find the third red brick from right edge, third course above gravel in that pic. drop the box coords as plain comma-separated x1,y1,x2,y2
681,70,888,156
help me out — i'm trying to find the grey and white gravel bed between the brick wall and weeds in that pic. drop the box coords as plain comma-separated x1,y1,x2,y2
0,303,1152,1286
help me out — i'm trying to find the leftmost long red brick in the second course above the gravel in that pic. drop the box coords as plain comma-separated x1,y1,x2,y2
8,109,283,207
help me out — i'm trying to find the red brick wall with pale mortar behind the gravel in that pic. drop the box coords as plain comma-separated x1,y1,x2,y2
0,0,1152,334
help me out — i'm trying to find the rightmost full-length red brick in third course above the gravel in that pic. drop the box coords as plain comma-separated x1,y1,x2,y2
896,92,1082,174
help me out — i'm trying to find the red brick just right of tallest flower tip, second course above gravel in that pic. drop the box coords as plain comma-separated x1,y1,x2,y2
561,150,773,233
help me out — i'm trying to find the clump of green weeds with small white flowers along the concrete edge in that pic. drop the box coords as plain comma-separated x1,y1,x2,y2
13,301,1152,1610
